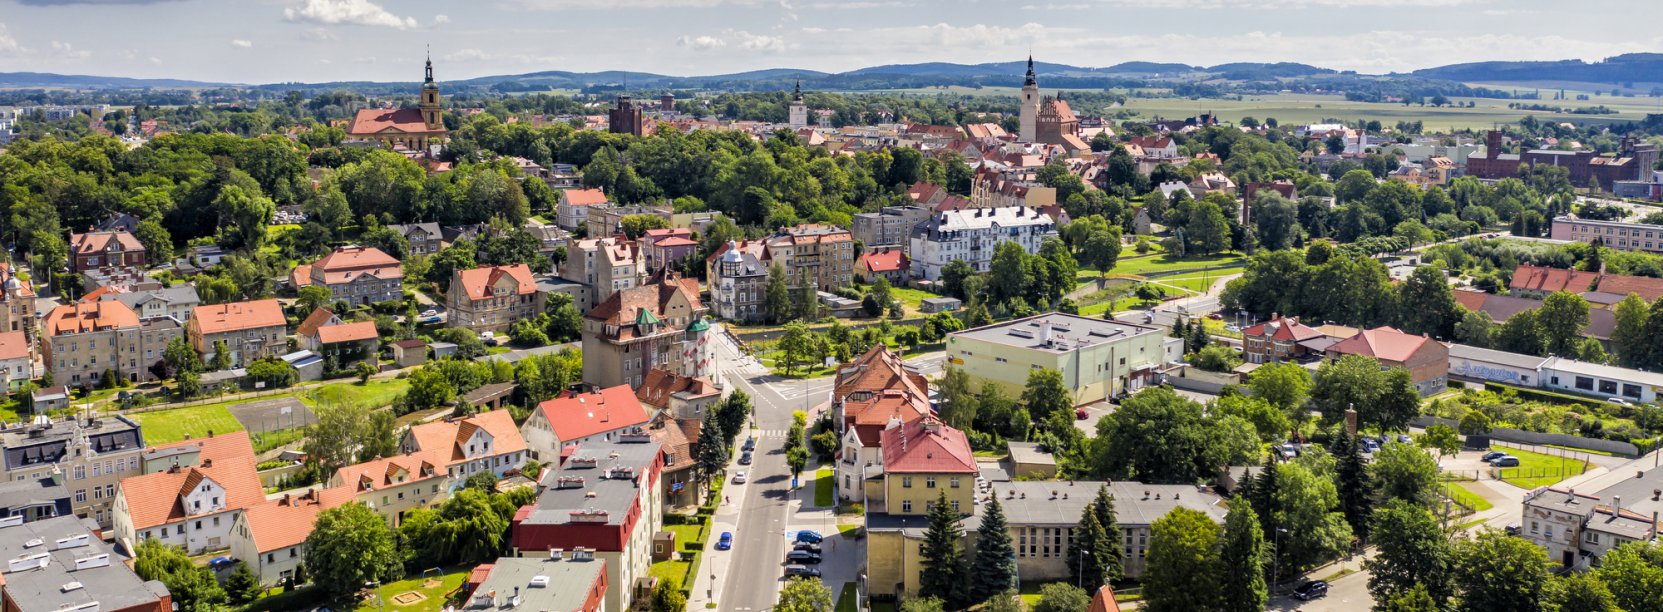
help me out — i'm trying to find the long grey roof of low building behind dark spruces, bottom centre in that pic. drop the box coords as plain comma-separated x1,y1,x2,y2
965,481,1227,529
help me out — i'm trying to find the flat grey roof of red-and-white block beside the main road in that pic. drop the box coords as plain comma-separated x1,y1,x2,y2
524,441,664,526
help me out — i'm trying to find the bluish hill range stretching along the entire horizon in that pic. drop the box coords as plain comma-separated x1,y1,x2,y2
0,53,1663,90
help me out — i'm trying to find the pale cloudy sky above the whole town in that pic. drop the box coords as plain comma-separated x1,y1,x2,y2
0,0,1663,83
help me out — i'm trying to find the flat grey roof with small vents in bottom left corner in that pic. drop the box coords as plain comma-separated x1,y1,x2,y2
0,516,168,612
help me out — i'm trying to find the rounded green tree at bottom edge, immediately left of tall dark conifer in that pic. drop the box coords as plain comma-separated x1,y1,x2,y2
1144,507,1222,612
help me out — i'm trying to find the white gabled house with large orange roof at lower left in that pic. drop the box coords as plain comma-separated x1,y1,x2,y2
113,432,266,554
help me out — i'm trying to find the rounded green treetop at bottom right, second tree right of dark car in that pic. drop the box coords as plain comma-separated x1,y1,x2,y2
1450,529,1548,612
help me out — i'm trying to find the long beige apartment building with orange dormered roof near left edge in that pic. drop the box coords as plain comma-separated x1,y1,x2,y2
42,301,183,387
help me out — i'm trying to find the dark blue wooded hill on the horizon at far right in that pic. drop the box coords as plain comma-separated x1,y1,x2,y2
1412,53,1663,85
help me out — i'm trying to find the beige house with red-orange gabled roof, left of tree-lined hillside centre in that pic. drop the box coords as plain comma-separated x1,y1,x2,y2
446,263,542,334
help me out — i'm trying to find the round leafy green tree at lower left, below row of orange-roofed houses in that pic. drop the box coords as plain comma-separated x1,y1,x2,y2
306,502,402,595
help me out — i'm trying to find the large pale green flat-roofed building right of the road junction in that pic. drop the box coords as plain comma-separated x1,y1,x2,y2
946,313,1182,404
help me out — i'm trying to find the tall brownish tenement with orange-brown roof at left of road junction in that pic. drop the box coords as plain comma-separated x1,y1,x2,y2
584,269,707,387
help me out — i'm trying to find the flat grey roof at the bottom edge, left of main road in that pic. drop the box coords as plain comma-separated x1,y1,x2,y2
462,554,607,610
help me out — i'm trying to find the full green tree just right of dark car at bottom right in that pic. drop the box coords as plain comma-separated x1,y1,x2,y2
1364,499,1453,604
